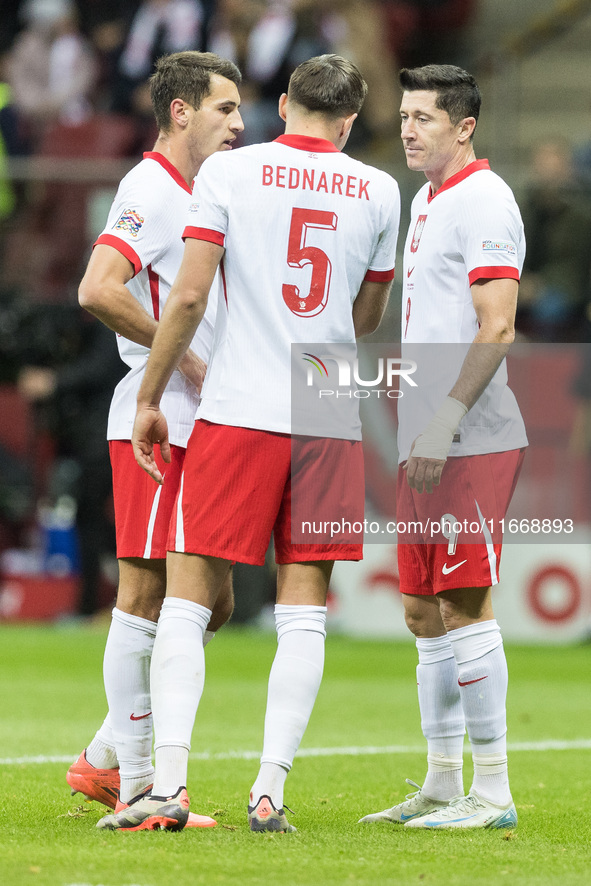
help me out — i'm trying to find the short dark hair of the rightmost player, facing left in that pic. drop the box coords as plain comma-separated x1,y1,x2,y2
398,65,482,126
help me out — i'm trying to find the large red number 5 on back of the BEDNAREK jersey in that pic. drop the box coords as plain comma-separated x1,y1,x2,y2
283,209,338,317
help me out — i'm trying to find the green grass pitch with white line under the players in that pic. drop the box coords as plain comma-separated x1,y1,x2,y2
0,625,591,886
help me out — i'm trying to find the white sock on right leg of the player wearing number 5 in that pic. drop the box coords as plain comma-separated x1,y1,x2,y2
250,603,326,809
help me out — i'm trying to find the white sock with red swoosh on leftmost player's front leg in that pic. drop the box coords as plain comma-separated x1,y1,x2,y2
103,608,156,803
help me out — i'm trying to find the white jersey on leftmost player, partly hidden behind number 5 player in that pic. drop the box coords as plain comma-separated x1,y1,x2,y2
96,152,217,446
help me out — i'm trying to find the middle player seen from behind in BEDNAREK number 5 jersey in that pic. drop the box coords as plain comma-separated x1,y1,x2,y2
98,55,400,832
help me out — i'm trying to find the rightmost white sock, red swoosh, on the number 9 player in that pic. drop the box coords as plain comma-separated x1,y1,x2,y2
447,619,511,806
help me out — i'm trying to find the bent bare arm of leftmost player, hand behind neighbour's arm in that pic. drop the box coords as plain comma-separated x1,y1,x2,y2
78,243,206,390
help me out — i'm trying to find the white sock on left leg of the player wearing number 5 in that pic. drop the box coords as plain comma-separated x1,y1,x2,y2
151,597,211,797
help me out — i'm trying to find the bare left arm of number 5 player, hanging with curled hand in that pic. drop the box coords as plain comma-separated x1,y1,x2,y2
131,239,224,483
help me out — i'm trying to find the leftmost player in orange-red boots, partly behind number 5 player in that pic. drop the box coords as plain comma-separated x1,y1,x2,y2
67,52,243,825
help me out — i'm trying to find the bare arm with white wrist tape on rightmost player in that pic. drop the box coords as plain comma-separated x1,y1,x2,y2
405,278,518,492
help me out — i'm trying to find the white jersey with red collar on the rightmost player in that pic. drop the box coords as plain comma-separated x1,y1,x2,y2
398,160,527,461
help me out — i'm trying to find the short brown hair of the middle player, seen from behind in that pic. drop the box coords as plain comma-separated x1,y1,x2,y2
287,54,367,117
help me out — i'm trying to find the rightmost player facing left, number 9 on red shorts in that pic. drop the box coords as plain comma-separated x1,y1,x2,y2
361,65,527,828
